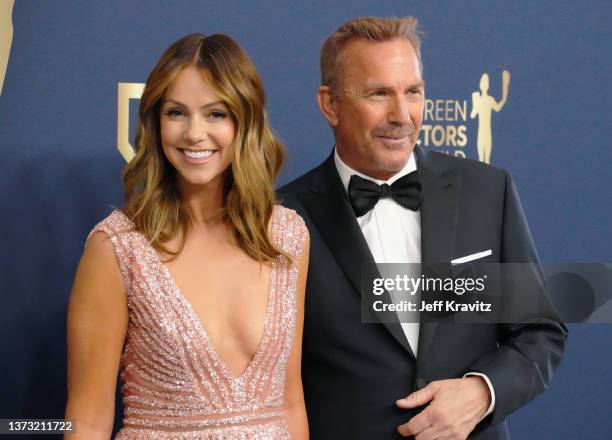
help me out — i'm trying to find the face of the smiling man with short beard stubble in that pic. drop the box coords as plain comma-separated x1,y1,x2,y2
324,39,425,180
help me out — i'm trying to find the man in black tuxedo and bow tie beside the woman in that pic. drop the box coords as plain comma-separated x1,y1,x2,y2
280,18,566,440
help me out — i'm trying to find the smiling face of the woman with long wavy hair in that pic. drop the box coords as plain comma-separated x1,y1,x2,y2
160,66,235,188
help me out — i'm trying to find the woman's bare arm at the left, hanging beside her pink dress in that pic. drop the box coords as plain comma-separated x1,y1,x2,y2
65,232,128,440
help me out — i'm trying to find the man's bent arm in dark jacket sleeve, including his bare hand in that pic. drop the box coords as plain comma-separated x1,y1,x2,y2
397,168,567,439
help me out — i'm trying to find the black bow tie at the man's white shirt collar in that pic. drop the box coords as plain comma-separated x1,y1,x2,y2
348,171,421,217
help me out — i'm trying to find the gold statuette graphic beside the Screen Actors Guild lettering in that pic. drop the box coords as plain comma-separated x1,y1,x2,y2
470,70,510,163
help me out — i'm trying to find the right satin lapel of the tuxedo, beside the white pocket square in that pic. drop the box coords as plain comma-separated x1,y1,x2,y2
415,147,461,364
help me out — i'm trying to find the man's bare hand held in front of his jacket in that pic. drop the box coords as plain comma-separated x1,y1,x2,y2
396,376,491,440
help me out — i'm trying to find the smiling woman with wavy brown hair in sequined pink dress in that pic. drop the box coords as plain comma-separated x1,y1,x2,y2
66,34,309,440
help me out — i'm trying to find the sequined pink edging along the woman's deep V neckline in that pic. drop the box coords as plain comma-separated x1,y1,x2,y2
154,245,276,381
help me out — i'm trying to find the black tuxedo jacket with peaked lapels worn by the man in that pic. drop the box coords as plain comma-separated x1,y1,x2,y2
279,147,567,440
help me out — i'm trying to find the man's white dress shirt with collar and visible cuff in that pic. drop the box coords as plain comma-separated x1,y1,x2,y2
334,149,495,418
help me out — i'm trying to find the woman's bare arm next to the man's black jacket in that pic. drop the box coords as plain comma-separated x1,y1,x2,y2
285,232,310,440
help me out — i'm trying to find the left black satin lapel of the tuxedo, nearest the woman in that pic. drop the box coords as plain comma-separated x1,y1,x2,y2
298,154,414,357
